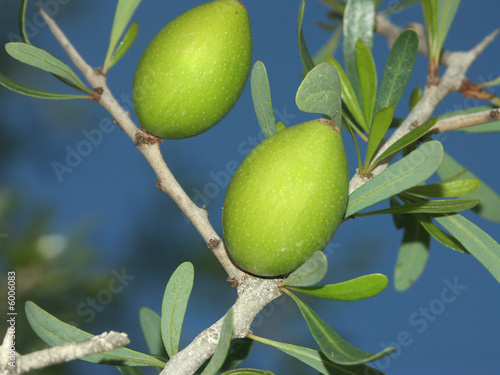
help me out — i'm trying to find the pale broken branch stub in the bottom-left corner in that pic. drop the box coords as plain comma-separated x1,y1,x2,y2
0,331,130,375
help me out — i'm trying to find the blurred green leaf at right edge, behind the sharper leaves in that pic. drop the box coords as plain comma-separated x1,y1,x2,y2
437,152,500,222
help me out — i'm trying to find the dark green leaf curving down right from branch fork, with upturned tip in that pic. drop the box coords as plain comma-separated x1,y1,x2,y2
285,289,394,365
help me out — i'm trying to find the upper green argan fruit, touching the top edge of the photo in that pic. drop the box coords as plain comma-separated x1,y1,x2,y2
133,0,252,139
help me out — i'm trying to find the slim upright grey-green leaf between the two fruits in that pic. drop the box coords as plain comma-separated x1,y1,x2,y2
250,61,278,138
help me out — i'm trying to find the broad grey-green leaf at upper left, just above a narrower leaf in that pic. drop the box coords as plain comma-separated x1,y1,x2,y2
5,42,92,94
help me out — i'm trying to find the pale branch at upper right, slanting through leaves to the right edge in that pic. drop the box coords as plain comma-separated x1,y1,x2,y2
349,24,500,194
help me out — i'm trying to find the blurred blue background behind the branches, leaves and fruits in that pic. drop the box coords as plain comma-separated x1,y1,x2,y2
0,0,500,375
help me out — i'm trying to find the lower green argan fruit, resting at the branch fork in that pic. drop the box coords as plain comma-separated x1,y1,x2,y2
222,119,349,276
